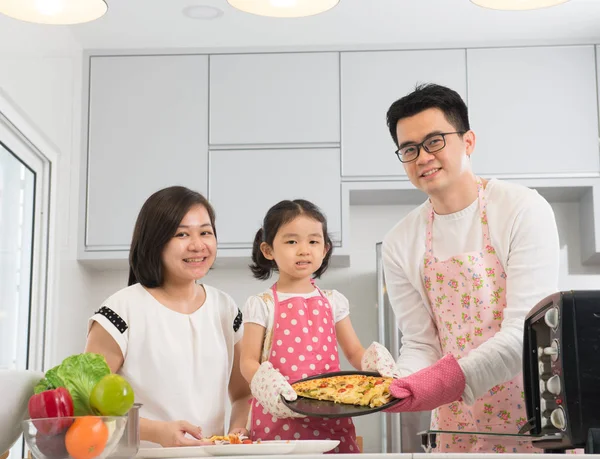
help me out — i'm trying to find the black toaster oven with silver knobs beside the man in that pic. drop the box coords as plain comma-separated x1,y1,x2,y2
523,290,600,453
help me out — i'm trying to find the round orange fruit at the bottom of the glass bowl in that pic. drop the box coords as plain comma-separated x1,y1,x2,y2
65,416,108,459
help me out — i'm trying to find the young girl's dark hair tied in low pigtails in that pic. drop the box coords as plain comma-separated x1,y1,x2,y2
250,199,333,280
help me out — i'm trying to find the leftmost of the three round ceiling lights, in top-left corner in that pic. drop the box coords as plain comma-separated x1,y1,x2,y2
0,0,108,25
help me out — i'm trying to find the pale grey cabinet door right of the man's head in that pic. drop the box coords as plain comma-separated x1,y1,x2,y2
467,46,599,175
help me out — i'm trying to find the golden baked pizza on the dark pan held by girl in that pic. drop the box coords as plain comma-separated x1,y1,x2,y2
292,375,393,408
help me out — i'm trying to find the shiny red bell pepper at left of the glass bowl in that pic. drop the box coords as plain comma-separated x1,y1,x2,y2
28,387,73,435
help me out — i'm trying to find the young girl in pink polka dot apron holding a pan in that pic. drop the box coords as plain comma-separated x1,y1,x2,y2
241,199,395,453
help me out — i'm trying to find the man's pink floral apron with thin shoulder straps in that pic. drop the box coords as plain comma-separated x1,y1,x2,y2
424,178,542,453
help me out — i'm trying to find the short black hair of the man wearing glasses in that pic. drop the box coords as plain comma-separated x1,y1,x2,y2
387,83,471,146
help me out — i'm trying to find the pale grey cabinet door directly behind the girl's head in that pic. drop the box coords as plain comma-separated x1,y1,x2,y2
209,148,341,248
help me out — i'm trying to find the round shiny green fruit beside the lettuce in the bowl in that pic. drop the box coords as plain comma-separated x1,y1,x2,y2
90,374,134,416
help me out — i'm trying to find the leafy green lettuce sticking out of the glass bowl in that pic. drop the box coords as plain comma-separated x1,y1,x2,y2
34,353,110,416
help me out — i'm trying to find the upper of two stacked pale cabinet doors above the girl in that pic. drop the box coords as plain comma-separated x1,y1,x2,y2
210,53,340,145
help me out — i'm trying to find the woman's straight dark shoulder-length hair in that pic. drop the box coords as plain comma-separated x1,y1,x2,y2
128,186,217,288
